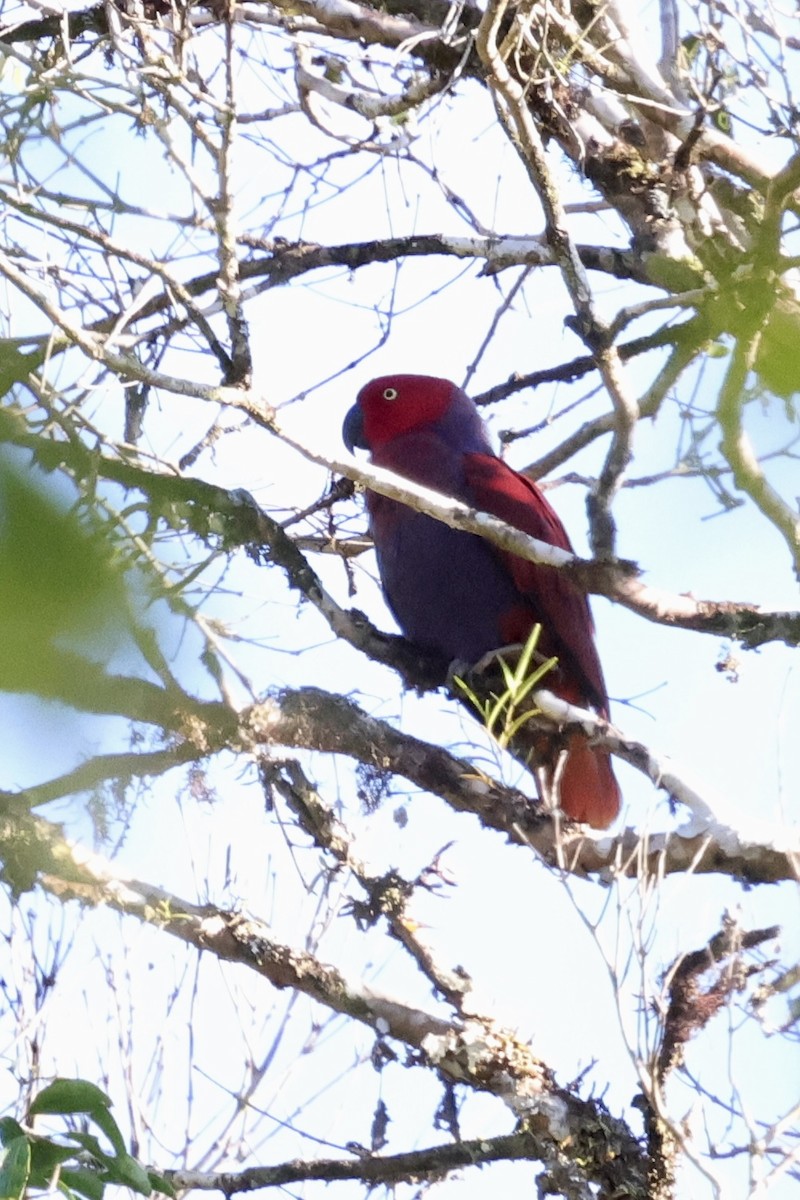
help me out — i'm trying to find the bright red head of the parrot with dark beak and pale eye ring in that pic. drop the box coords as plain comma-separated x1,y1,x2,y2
342,376,460,454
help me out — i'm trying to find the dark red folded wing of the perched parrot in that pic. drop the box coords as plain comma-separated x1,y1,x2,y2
464,454,608,715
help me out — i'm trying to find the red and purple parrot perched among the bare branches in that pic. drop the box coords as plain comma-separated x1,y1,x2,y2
342,374,620,829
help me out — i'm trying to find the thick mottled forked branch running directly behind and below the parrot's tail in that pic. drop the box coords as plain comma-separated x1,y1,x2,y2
242,688,800,883
